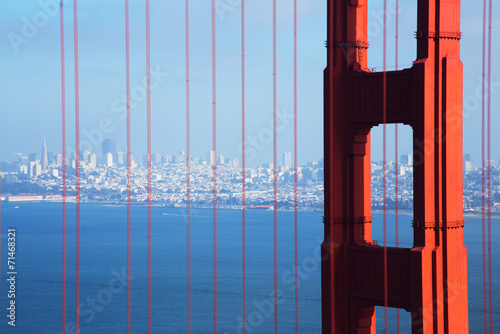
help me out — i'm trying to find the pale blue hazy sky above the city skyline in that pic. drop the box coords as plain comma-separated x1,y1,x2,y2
0,0,500,166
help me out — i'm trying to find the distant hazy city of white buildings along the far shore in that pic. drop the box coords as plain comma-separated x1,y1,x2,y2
0,139,500,213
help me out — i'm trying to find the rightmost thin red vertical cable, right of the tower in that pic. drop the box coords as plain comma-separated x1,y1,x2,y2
488,0,493,334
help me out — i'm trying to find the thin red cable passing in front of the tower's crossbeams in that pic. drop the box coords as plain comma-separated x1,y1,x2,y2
383,0,389,334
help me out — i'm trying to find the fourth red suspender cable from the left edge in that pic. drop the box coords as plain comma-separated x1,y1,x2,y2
146,0,153,334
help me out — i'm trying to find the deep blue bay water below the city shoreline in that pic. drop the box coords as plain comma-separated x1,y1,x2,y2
0,203,500,334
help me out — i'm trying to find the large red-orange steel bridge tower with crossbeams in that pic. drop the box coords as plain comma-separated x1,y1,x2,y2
322,0,468,334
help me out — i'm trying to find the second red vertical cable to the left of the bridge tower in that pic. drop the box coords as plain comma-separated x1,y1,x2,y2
273,0,278,334
